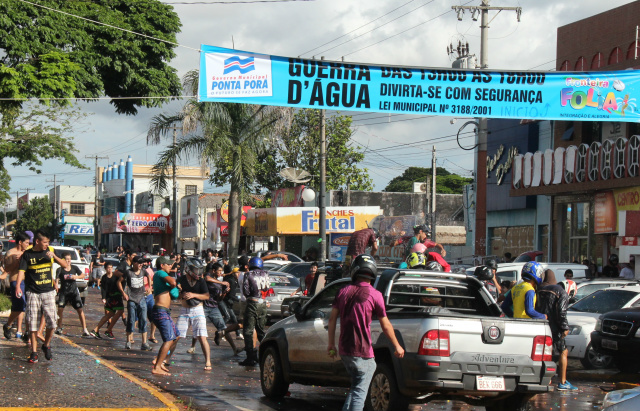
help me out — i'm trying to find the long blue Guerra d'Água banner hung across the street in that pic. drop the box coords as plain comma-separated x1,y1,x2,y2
198,45,640,122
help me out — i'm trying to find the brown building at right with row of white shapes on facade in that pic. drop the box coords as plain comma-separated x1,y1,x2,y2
510,1,640,265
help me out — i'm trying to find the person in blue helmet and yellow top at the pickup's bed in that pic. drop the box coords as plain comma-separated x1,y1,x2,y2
502,261,547,320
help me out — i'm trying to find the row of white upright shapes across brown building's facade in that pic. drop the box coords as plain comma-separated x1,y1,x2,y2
512,135,640,189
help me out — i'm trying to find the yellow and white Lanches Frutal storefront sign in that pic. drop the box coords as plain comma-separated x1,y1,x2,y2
247,207,380,236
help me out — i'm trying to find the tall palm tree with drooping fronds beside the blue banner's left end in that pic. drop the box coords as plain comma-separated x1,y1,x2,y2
147,70,292,261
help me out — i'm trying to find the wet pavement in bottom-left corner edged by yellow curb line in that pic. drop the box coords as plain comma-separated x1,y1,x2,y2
0,336,178,411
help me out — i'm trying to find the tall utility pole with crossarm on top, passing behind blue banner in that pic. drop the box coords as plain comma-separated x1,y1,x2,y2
451,0,522,255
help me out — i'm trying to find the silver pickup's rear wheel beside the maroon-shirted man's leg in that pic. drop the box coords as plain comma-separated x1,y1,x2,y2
365,363,409,411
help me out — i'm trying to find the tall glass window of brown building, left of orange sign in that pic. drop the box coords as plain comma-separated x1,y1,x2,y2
561,203,595,262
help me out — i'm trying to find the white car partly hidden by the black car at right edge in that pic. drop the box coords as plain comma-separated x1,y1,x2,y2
565,285,640,369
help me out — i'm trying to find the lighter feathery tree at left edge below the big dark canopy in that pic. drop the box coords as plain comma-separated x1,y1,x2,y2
0,104,86,204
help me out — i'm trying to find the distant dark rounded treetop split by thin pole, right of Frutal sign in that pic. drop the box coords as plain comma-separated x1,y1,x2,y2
384,167,473,194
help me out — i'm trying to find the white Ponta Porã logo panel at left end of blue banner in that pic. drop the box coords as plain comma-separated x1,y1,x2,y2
205,53,273,98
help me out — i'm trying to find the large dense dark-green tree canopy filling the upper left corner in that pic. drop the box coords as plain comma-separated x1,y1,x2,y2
0,0,181,114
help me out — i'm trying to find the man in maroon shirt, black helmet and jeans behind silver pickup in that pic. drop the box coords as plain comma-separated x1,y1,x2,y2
327,254,404,411
